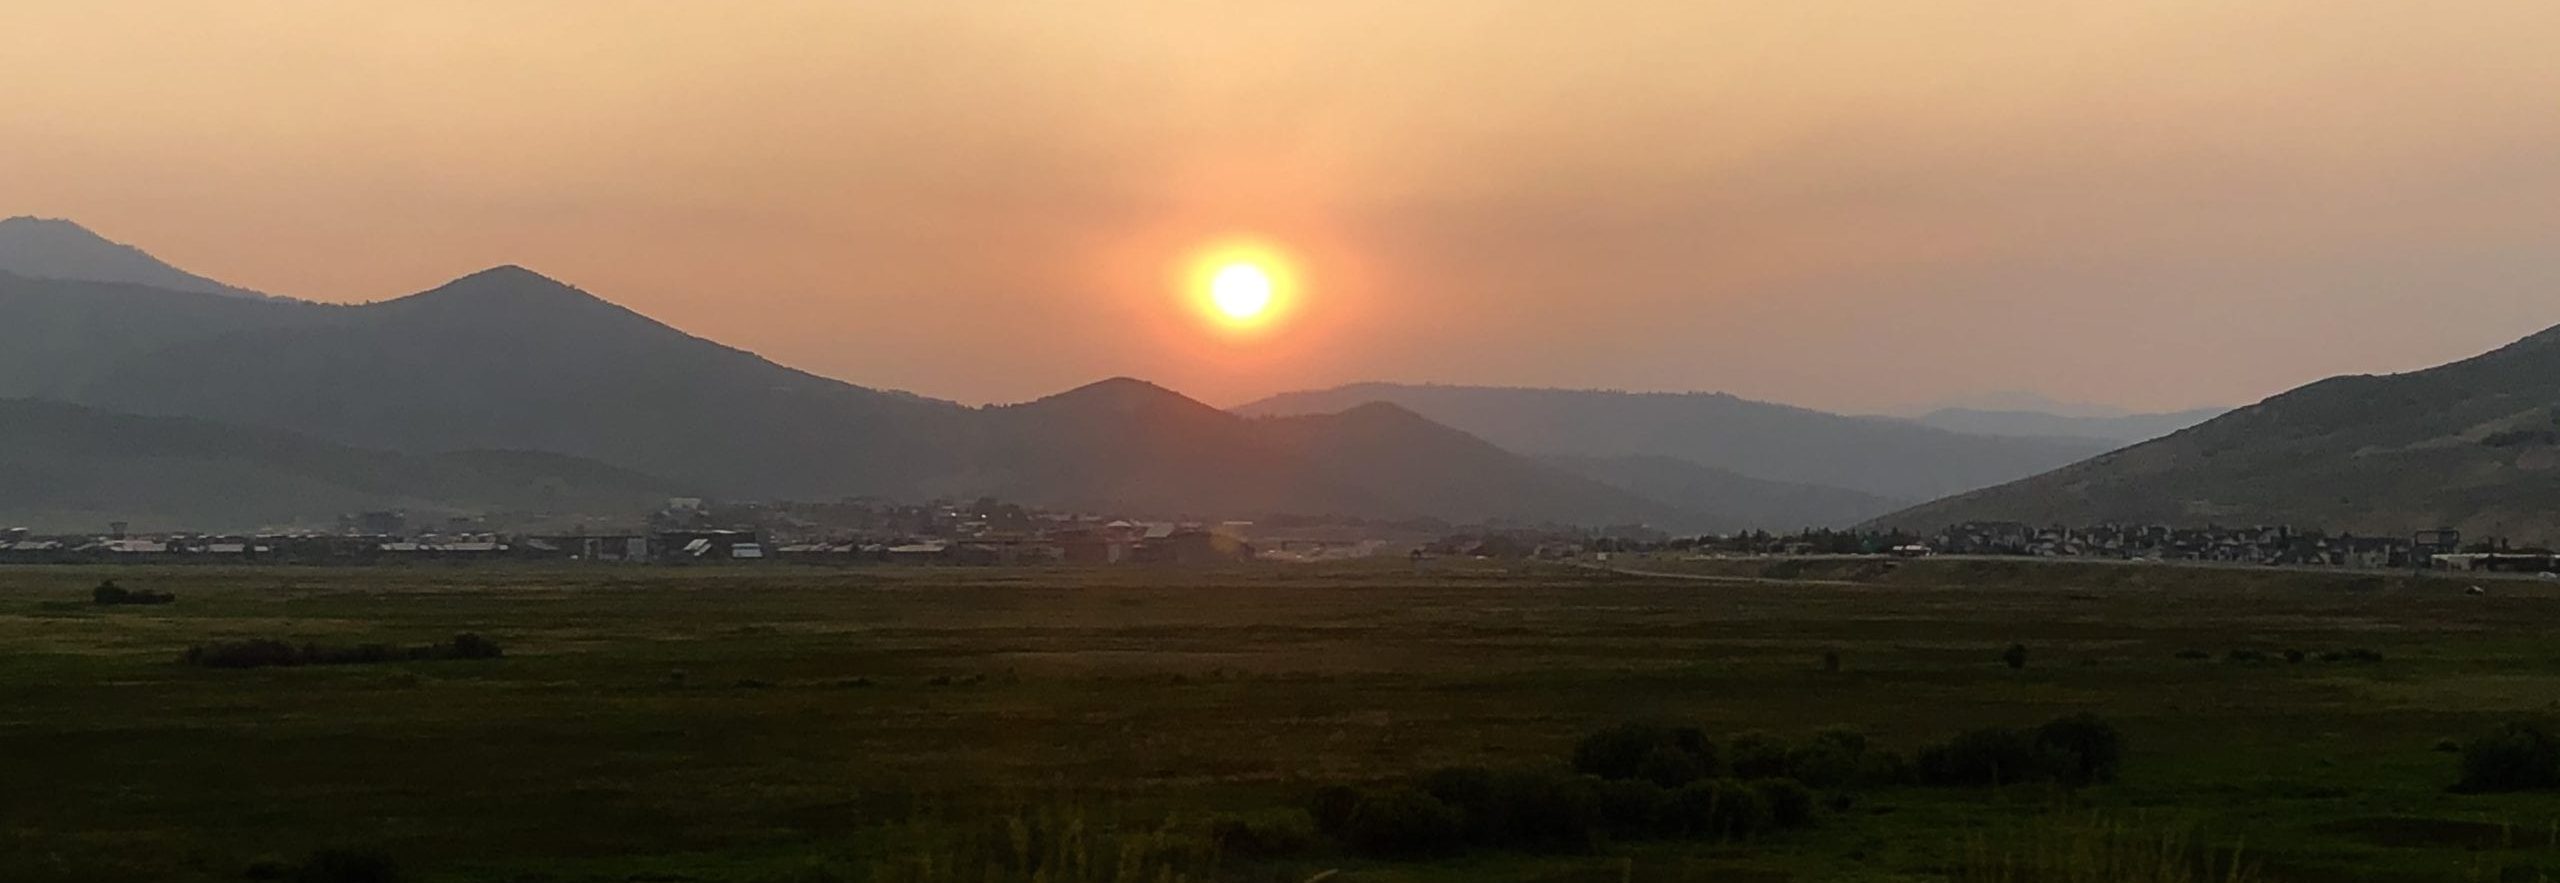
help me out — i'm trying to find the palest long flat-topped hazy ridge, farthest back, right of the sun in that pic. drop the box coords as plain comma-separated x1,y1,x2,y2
1236,384,2112,499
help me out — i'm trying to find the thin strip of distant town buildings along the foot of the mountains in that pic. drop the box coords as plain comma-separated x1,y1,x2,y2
0,497,2560,576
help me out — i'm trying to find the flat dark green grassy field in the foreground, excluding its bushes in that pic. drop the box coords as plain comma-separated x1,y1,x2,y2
0,561,2560,883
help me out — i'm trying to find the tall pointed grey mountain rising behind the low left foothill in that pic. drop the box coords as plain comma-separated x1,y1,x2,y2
35,266,970,497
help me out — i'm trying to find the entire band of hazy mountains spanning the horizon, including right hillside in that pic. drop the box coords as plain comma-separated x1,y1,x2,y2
30,218,2498,535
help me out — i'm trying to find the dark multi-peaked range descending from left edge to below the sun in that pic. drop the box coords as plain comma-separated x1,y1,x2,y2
15,266,1687,525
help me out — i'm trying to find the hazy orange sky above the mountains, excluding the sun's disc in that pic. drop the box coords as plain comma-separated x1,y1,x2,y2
0,0,2560,410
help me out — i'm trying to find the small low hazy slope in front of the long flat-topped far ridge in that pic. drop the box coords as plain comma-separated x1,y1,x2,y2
1539,453,1910,532
